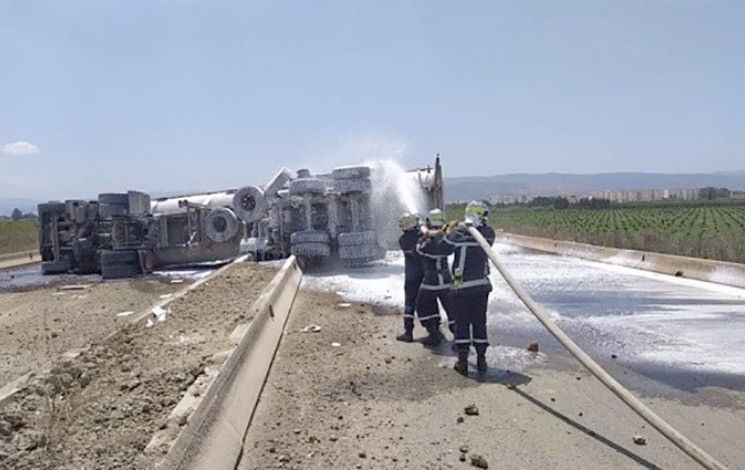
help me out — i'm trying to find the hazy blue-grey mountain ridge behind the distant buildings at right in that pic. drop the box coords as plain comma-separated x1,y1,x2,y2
445,171,745,202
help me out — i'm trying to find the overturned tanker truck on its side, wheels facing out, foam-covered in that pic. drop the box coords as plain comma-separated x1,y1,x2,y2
38,158,444,279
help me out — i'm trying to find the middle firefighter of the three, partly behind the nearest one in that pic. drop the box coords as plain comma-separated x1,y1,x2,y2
416,209,455,347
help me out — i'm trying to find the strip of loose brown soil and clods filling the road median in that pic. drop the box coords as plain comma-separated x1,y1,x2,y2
0,264,276,469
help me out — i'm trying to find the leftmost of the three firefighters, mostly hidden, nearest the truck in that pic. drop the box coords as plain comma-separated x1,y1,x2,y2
396,213,427,343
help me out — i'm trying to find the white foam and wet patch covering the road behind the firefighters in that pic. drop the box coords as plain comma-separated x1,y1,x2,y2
303,244,745,374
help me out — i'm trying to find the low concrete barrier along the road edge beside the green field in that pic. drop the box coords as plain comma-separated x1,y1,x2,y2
497,233,745,288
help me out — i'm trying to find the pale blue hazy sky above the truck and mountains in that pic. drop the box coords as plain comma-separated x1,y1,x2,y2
0,0,745,199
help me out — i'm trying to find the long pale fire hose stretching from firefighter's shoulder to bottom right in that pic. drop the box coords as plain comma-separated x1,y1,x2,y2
468,226,727,469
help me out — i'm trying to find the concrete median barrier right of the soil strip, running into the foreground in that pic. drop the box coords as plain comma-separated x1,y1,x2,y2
158,256,302,470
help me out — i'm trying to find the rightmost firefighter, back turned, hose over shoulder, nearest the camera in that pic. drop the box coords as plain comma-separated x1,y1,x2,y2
441,201,495,375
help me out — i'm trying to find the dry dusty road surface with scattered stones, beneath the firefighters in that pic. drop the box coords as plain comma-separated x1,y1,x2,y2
239,290,745,470
